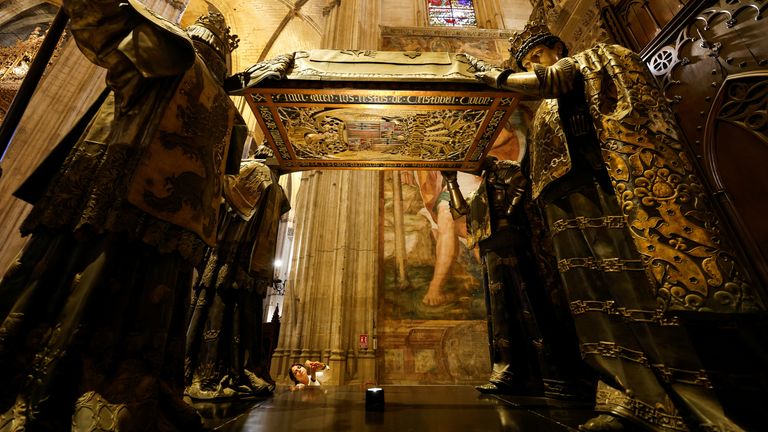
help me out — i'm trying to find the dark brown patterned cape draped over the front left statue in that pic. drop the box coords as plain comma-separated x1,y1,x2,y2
22,2,243,253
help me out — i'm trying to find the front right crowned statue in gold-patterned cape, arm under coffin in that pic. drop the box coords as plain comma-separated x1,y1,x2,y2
469,16,765,431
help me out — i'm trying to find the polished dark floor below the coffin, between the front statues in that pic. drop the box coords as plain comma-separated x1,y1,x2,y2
193,386,594,432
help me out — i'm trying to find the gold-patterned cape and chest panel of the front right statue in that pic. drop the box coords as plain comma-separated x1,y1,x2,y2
531,44,765,313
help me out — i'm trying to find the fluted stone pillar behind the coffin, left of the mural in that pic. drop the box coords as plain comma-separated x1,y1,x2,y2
270,0,380,384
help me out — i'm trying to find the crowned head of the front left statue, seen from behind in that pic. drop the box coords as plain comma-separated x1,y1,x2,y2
186,12,240,82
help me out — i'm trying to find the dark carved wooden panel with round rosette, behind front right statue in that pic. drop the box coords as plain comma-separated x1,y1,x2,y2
642,0,768,286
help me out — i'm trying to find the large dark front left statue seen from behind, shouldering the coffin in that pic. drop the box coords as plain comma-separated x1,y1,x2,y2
0,0,242,432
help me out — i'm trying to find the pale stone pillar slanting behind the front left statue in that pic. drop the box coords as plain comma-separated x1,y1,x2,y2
0,0,188,273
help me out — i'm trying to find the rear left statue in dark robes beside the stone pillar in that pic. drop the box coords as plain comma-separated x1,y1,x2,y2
185,154,290,399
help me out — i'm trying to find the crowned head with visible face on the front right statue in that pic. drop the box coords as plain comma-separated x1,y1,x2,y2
509,19,568,71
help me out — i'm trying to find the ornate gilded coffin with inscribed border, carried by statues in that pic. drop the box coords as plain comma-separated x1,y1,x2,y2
227,50,519,171
